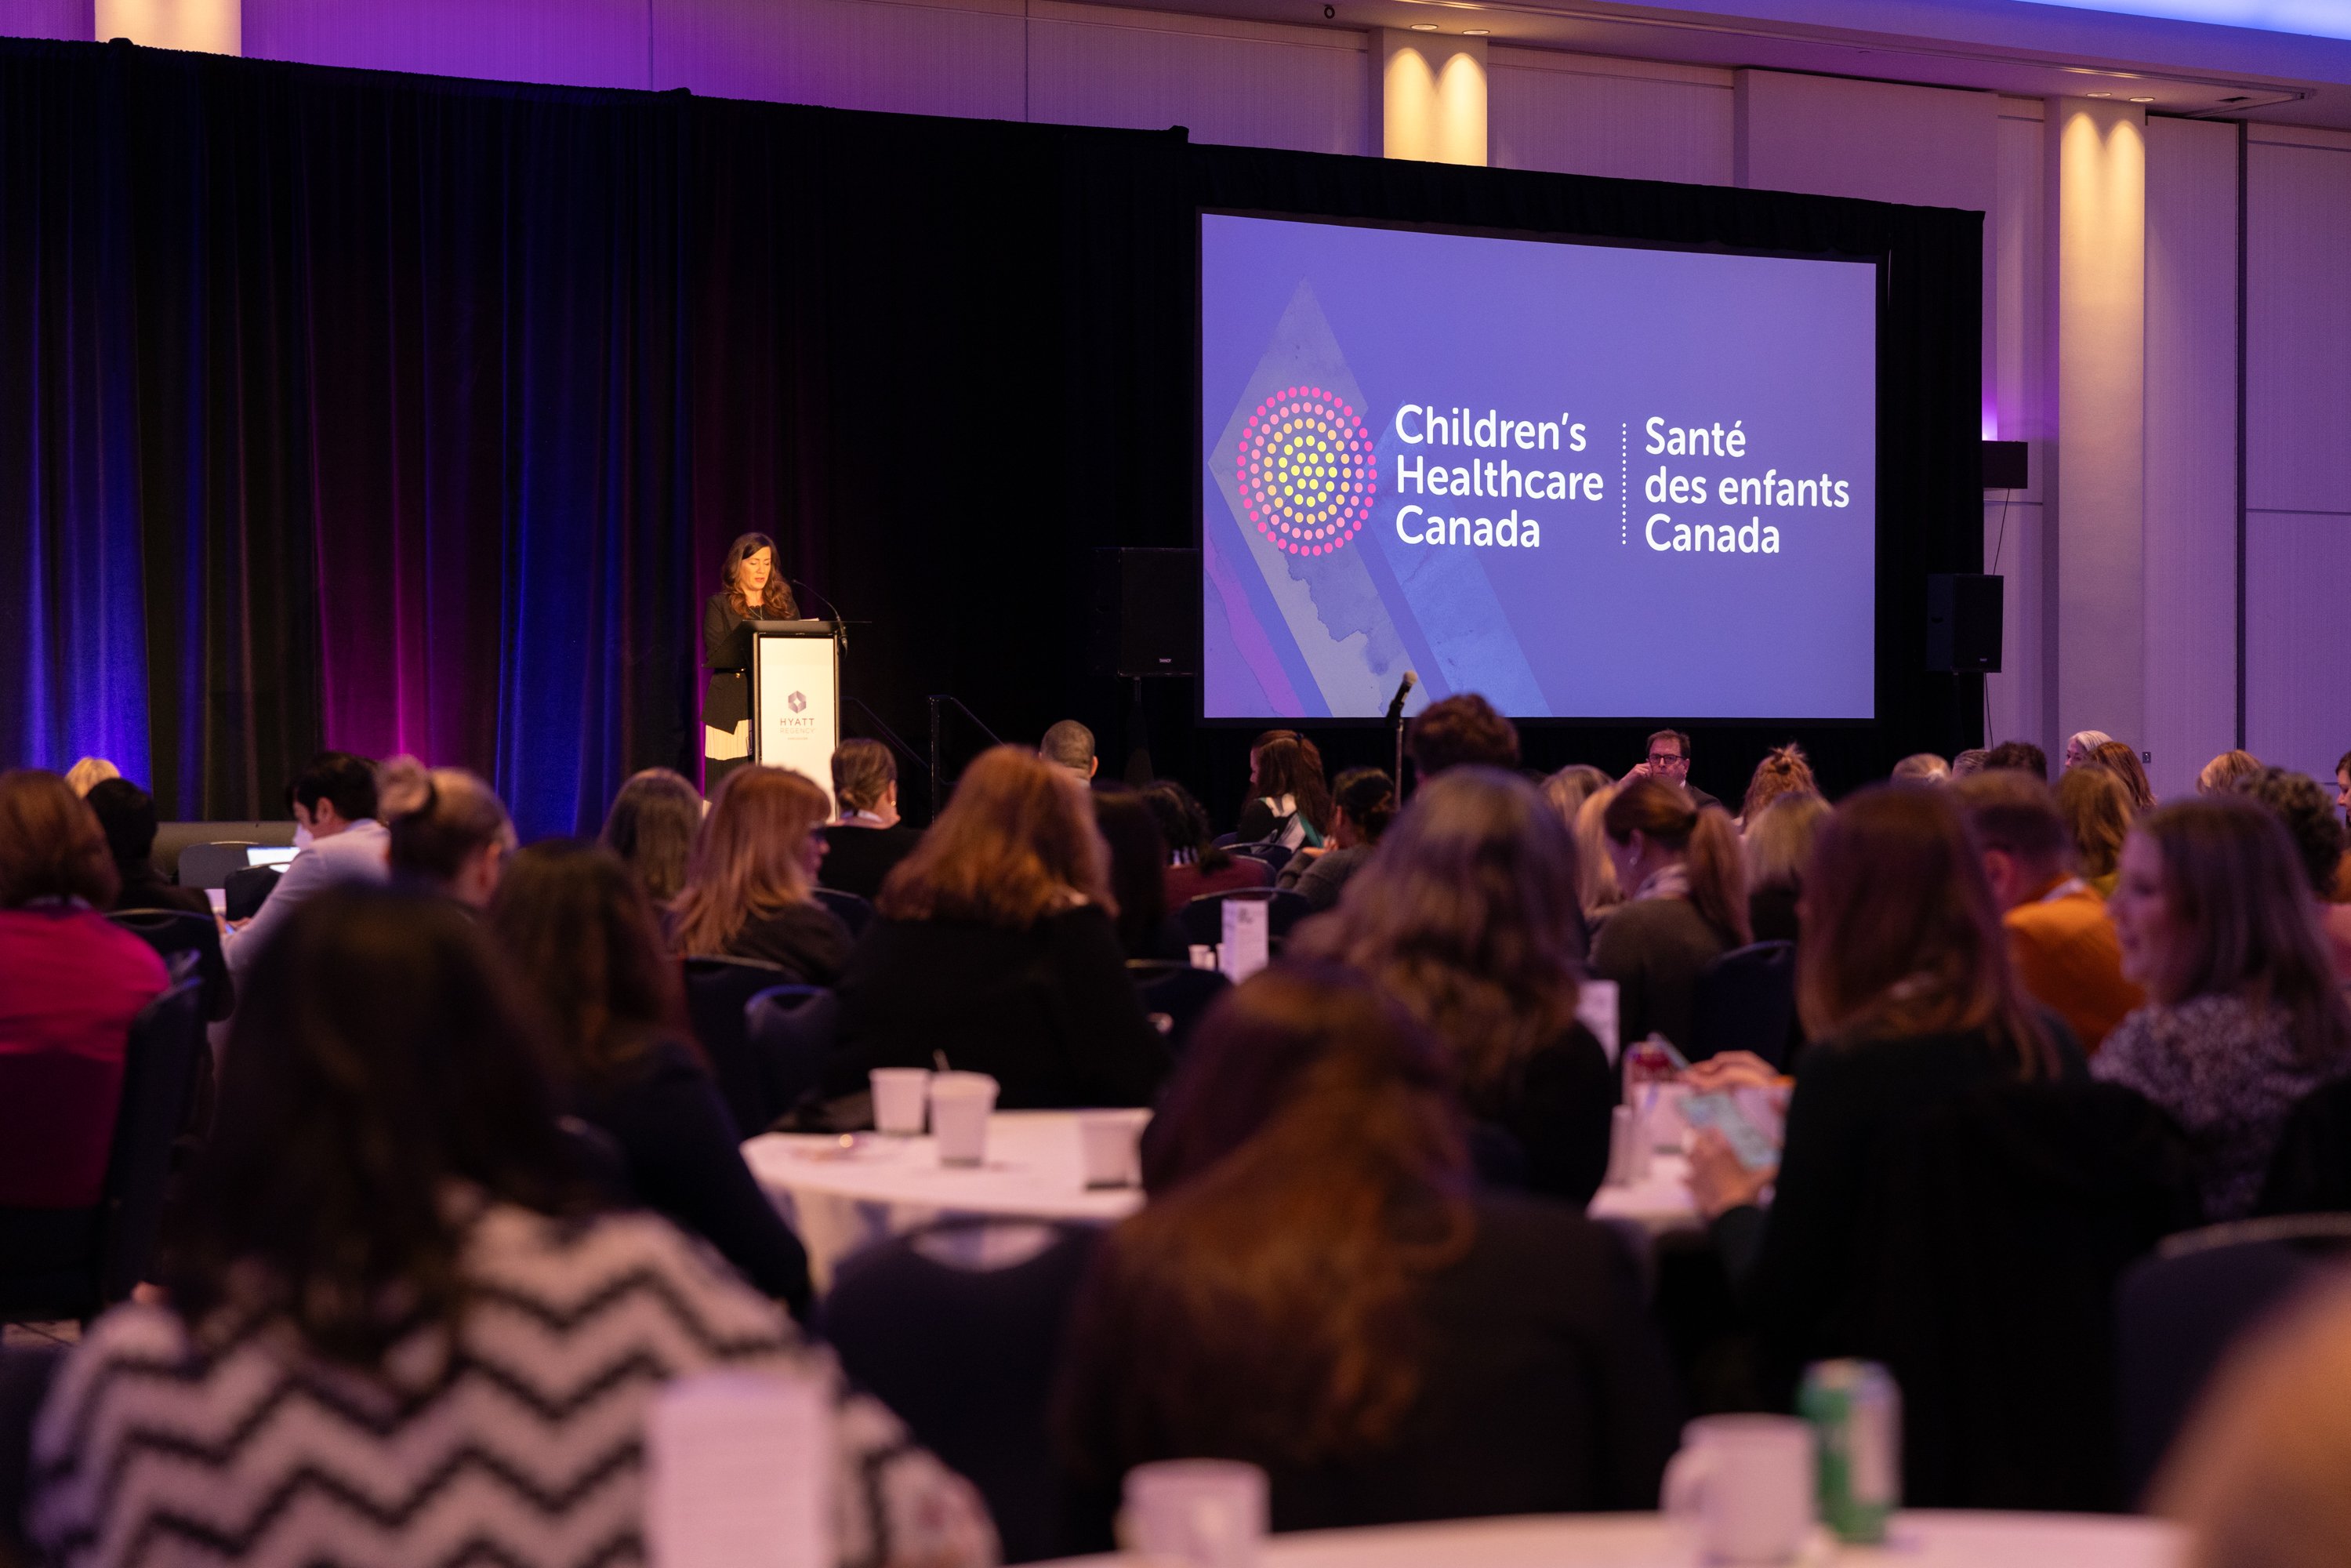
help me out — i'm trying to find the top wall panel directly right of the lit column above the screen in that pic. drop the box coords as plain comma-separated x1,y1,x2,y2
1486,47,1730,186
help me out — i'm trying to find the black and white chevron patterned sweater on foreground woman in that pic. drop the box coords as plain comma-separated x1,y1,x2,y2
26,1206,995,1568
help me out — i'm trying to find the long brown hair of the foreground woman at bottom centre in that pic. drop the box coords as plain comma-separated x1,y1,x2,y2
1065,964,1474,1462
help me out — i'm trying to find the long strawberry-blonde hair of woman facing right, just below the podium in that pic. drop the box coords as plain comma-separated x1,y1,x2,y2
670,767,825,952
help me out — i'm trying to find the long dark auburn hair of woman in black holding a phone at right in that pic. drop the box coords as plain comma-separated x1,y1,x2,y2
1796,785,2057,1079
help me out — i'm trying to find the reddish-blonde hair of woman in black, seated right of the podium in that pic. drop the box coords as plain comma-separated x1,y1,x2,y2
875,746,1119,928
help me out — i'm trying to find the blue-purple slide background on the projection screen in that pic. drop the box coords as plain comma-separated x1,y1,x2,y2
1201,214,1876,720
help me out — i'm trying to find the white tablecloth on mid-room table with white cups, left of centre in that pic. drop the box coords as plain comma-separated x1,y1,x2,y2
743,1109,1143,1290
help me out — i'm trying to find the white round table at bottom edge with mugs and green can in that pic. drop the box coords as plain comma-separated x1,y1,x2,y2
1039,1509,2186,1568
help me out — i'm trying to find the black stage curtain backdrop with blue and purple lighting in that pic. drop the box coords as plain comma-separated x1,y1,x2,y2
0,45,1982,834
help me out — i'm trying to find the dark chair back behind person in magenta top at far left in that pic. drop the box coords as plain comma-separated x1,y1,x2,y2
96,978,207,1305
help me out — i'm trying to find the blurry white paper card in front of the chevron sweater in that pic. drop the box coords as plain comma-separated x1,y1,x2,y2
644,1373,833,1568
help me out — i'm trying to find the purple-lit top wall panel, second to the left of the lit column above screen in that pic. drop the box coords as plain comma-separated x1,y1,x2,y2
651,0,1028,120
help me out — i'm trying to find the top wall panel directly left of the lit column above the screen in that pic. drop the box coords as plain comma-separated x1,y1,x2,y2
1030,0,1380,155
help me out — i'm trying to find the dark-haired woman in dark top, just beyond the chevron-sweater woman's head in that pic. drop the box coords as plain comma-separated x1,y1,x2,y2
489,839,809,1316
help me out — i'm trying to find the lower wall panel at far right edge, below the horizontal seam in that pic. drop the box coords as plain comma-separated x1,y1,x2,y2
2245,513,2351,783
